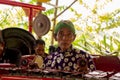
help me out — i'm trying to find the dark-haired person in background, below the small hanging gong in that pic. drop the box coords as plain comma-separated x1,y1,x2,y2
30,39,48,68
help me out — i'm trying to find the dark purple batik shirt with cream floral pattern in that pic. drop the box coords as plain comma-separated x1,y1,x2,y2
44,47,95,72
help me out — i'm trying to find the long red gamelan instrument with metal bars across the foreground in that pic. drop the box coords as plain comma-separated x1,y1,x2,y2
0,63,120,80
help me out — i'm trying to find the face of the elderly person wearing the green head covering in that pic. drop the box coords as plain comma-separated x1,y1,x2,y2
55,27,76,51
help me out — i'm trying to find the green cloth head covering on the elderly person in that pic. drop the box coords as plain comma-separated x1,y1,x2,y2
54,20,75,34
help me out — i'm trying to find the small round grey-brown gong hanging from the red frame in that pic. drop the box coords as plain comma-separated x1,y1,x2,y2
33,14,50,37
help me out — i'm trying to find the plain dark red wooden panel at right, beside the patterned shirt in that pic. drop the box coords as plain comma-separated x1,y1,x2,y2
93,55,120,78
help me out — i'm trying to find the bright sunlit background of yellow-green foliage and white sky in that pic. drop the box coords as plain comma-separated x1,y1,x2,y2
0,0,120,55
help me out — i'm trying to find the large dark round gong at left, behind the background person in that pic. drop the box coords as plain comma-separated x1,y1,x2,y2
2,27,35,55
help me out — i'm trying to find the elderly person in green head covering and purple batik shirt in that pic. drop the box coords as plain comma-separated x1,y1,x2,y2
44,20,95,74
